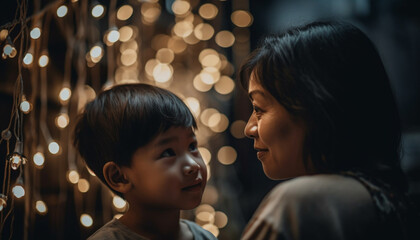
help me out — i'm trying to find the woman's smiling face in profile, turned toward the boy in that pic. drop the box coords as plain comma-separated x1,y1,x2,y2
245,74,306,179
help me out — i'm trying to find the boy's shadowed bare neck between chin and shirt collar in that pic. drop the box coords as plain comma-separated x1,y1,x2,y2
119,206,191,239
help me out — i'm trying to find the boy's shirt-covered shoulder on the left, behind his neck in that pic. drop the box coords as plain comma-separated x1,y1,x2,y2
88,218,147,240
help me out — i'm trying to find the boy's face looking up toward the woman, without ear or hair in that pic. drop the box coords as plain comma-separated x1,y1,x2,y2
122,127,207,209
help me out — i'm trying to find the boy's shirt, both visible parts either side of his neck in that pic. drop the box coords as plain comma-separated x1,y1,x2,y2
88,218,217,240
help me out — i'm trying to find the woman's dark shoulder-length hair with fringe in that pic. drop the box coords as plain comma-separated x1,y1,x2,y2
239,22,406,190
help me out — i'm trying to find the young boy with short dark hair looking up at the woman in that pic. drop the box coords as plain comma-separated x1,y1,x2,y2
74,84,216,240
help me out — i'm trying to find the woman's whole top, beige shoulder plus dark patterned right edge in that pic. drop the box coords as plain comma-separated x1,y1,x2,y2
242,172,420,240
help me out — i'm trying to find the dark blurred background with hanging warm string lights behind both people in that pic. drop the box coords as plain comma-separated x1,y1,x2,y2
0,0,420,239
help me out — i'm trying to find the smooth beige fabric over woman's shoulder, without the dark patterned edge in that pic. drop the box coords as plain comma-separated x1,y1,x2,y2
242,175,378,240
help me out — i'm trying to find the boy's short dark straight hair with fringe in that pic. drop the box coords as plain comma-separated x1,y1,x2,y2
74,83,197,195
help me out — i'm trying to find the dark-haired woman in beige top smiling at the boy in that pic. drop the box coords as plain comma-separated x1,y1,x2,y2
240,22,420,239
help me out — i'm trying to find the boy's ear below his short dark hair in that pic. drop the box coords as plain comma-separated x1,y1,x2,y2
102,162,131,193
